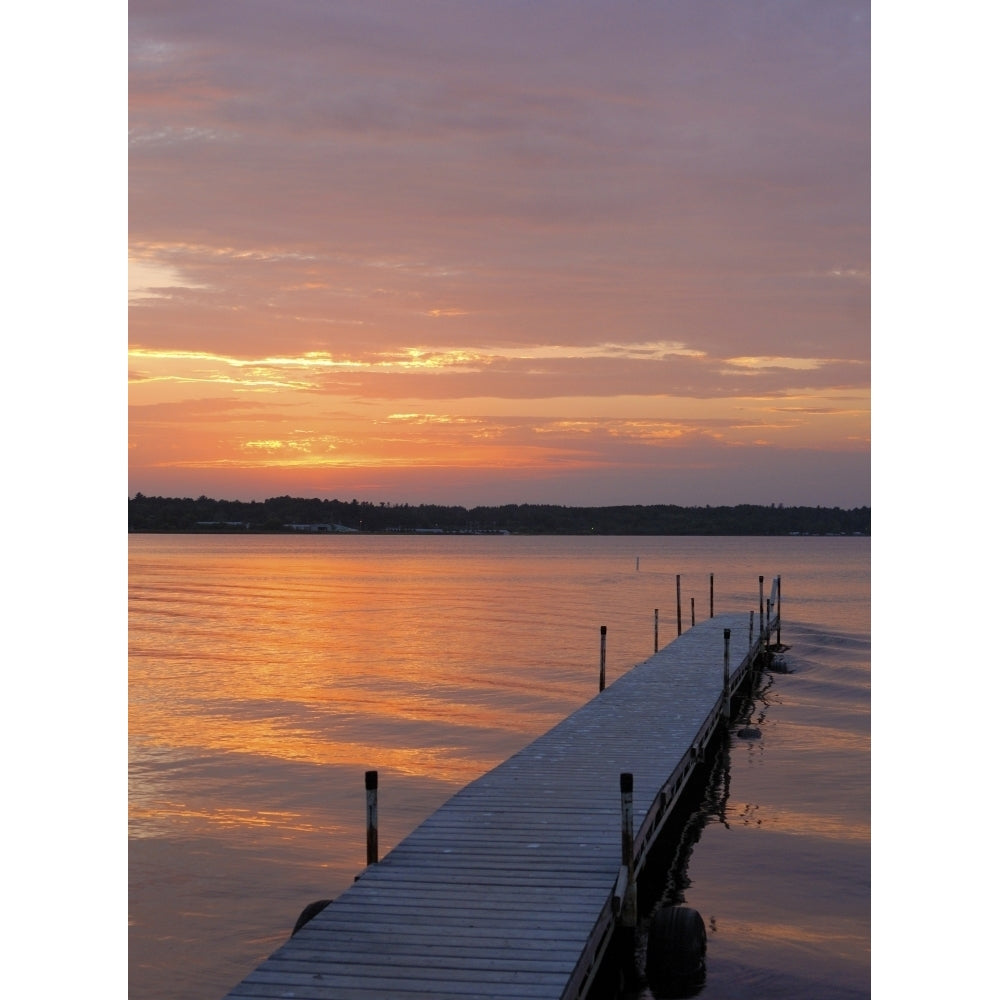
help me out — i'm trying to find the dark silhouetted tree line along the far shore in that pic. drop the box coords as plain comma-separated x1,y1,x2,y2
128,493,871,535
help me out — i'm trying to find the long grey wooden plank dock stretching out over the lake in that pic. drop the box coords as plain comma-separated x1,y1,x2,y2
228,579,780,1000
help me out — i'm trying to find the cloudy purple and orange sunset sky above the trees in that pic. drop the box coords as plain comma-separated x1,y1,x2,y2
128,0,871,508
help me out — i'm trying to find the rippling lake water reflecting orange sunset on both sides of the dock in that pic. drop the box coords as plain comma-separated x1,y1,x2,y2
129,535,870,1000
